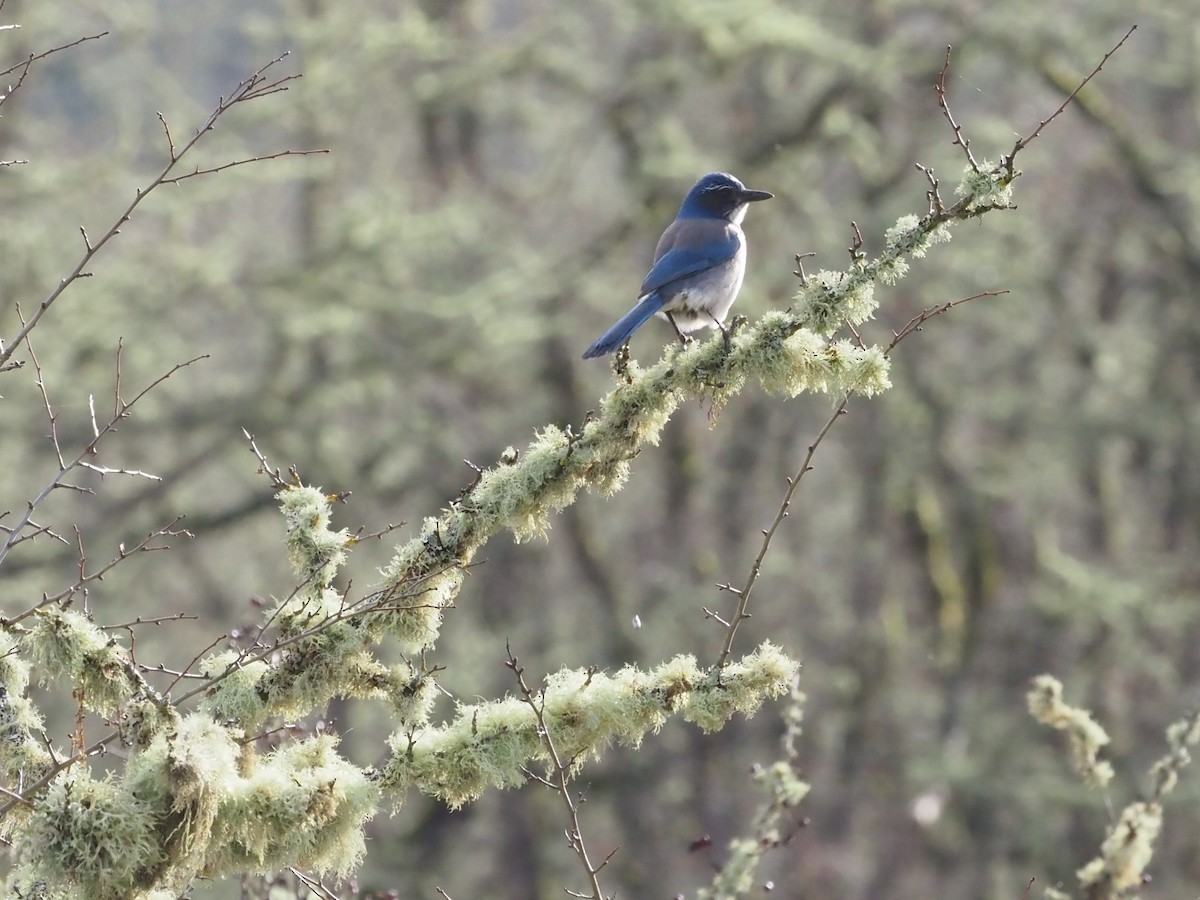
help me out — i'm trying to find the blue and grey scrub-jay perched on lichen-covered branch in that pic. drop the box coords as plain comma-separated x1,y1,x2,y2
583,172,774,359
